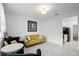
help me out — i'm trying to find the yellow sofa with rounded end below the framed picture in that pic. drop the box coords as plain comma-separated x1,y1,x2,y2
24,35,46,47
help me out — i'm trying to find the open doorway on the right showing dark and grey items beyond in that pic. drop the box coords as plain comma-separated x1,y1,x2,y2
63,16,78,49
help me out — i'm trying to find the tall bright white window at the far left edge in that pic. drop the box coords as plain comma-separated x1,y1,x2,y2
0,4,6,41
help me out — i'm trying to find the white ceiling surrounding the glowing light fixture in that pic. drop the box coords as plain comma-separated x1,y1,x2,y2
3,3,79,19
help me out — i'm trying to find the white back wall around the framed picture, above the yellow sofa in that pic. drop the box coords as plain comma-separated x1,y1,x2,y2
6,14,41,40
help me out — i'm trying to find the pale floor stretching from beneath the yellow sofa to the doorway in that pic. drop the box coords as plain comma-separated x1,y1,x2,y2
24,42,79,56
